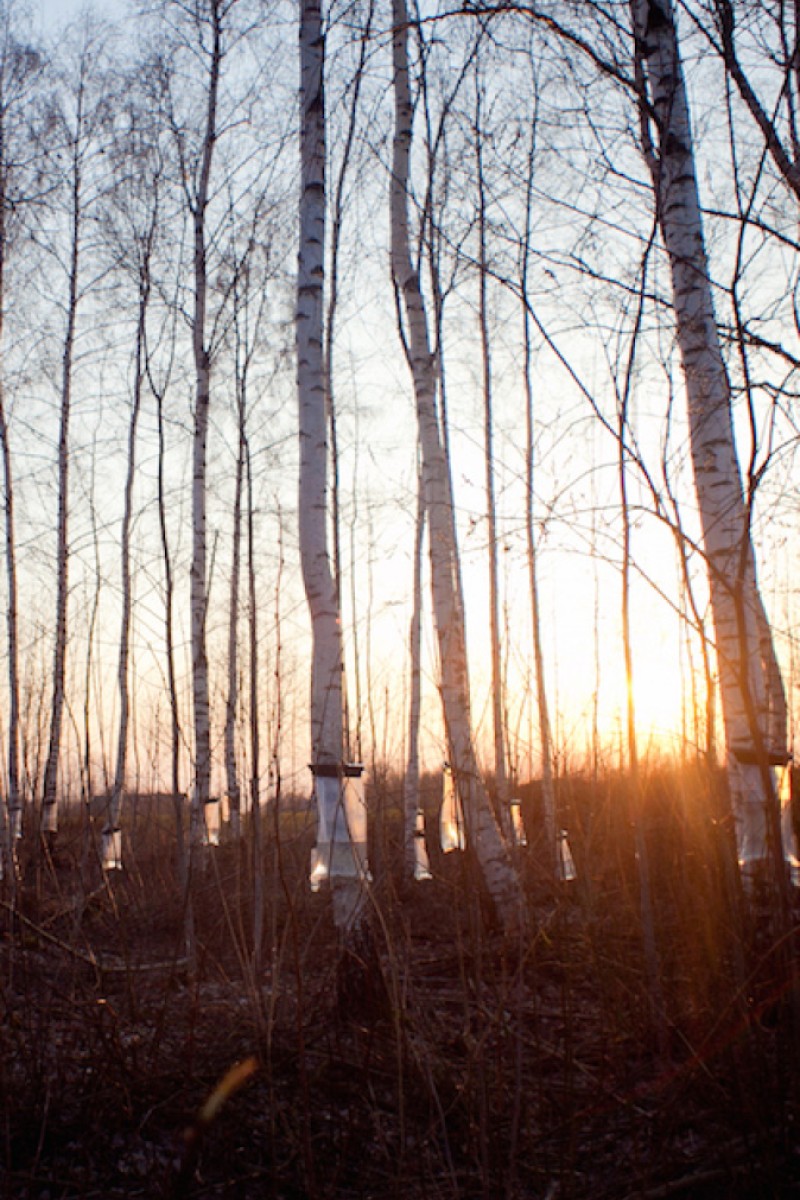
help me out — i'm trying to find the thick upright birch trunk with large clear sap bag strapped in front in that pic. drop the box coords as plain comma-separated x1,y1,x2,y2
296,0,365,932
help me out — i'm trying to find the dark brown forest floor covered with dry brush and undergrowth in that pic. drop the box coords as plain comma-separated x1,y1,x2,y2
0,772,800,1200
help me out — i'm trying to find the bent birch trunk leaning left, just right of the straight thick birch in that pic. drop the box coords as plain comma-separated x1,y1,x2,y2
391,0,523,929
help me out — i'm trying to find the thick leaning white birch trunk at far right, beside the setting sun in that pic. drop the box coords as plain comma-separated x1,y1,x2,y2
631,0,793,874
